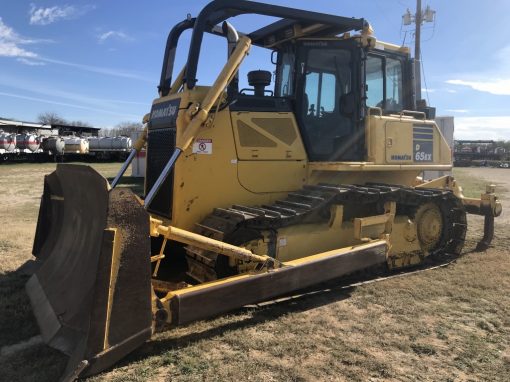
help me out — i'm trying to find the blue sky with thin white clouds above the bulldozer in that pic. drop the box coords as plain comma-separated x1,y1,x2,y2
0,0,510,139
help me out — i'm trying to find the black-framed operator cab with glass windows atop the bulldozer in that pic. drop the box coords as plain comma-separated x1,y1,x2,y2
231,32,413,162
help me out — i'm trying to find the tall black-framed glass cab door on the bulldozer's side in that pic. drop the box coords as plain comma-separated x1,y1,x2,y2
296,40,365,162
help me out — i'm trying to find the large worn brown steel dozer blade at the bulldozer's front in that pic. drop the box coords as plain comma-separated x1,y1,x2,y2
26,165,152,381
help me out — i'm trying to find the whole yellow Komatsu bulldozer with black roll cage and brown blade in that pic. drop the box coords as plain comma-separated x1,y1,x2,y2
26,0,501,380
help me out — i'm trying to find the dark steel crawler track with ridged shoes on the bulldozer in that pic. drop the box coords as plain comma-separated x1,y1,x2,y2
186,183,467,282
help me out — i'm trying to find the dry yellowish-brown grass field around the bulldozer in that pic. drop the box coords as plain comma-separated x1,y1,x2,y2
0,164,510,382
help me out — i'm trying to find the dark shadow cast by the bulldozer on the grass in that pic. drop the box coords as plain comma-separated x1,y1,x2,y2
0,250,474,381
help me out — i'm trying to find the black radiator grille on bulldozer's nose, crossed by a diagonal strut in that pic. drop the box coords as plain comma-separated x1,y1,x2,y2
146,128,176,219
